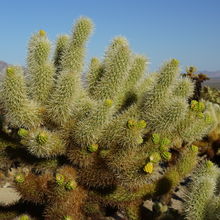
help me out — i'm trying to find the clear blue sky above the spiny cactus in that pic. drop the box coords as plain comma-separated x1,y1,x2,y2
0,0,220,71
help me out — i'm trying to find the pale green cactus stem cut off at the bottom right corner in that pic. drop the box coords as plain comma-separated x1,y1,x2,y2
185,161,220,220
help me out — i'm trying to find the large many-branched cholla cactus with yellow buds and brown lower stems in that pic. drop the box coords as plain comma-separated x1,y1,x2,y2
0,17,217,220
